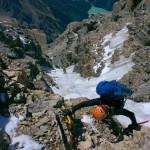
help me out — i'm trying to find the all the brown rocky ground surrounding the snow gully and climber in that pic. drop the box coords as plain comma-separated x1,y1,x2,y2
0,0,150,150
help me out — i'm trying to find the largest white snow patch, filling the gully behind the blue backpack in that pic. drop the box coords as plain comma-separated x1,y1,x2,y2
48,54,134,99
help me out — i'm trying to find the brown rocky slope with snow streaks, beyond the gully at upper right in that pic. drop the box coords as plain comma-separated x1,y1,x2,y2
46,0,150,101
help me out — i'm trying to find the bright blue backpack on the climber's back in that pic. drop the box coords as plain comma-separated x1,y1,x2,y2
96,80,132,100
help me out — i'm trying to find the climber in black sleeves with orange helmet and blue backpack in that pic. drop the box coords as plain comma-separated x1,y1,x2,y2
62,80,140,130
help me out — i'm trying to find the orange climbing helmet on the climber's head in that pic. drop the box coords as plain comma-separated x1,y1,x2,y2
92,104,110,120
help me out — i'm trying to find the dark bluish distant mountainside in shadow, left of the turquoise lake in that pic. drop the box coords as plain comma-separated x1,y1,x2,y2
0,0,117,43
